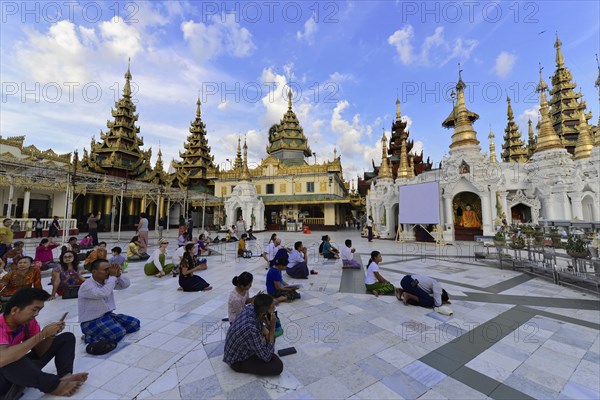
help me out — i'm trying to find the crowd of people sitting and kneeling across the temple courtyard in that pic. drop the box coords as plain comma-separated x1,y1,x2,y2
0,214,449,397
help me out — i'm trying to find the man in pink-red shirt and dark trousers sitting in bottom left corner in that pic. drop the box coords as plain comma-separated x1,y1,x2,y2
0,288,88,399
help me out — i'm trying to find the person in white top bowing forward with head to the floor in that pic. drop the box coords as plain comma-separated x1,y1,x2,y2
396,275,450,308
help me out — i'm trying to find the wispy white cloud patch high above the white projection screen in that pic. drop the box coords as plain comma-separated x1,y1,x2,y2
388,25,479,67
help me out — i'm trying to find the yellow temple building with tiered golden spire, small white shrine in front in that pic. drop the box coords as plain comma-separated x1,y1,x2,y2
207,91,360,230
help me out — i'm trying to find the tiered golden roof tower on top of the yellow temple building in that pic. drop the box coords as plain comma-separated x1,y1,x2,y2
267,90,312,165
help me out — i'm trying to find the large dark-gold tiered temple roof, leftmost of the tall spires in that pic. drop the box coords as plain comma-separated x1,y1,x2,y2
81,61,155,181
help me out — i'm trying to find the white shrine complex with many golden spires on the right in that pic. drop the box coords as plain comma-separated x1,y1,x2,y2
366,38,600,241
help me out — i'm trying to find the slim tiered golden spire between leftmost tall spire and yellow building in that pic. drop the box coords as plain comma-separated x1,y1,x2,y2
171,99,214,192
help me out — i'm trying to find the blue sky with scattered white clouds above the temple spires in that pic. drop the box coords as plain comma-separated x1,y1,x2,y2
0,1,600,184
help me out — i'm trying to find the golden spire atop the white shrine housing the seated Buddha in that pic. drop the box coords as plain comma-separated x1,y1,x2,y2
442,64,479,149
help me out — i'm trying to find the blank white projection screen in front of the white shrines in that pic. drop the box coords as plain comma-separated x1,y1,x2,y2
398,182,440,225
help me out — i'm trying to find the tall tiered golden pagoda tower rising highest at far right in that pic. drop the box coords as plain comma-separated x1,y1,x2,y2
549,35,591,154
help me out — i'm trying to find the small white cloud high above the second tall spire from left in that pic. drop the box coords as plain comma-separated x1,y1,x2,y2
181,14,256,61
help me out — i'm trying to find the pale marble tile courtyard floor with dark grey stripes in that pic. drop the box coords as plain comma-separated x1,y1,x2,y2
16,231,600,399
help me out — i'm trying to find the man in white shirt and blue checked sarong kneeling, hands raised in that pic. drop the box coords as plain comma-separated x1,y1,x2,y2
78,259,140,343
